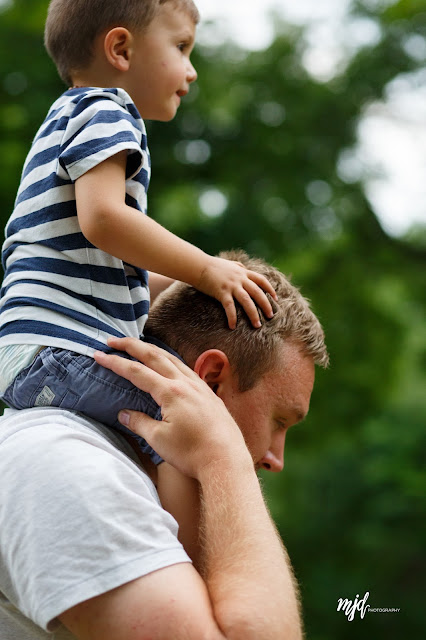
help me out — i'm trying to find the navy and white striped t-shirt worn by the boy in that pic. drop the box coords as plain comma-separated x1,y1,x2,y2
0,87,150,355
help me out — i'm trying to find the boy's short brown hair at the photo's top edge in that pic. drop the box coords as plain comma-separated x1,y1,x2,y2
44,0,199,86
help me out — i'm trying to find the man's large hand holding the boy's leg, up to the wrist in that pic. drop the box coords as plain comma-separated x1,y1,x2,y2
95,338,253,479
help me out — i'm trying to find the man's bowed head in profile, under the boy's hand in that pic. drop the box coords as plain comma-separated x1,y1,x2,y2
146,252,328,471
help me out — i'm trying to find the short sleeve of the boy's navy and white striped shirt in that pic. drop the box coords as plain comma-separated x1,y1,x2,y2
59,89,149,181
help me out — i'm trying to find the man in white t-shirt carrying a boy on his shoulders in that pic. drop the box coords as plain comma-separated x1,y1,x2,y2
0,254,328,640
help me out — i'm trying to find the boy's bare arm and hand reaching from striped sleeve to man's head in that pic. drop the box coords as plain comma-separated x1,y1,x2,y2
75,151,276,328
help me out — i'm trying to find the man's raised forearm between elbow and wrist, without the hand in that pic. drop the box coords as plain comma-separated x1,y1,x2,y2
200,464,302,640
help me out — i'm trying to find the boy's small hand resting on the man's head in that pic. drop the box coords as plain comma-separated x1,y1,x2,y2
194,256,277,329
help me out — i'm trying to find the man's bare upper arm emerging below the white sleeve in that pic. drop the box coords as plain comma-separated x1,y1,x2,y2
60,563,226,640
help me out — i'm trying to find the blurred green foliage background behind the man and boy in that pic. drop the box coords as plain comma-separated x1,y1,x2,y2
0,0,426,640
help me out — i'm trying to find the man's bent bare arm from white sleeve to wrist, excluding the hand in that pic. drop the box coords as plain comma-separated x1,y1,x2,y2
60,467,302,640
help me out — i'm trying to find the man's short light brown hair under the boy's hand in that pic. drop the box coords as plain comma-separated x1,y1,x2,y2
145,251,329,391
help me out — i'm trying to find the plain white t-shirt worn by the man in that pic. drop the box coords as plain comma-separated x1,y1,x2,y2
0,408,190,640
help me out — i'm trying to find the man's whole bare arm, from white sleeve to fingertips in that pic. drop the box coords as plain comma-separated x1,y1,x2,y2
61,339,302,640
